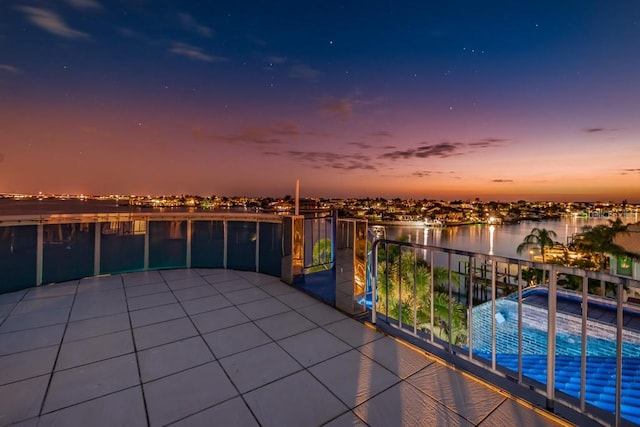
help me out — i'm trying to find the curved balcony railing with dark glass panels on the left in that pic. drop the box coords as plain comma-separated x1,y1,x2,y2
0,213,283,293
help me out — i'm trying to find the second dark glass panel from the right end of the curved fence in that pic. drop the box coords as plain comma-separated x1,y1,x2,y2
227,221,257,271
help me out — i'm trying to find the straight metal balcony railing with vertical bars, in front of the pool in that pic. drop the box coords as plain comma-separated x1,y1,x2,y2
367,240,640,425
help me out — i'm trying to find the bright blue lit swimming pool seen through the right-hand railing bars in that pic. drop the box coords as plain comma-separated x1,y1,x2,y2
472,298,640,424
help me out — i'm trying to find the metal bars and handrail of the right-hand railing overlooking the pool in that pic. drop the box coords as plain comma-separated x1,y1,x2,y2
370,238,640,425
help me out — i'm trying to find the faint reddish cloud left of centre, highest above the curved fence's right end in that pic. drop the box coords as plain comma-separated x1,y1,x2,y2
191,121,324,145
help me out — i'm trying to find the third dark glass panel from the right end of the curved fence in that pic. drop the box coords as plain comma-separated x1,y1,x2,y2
191,221,224,268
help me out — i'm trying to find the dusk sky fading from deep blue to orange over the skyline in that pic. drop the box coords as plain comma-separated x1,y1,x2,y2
0,0,640,202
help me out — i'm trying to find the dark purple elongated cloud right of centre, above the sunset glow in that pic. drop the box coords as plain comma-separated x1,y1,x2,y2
380,138,507,160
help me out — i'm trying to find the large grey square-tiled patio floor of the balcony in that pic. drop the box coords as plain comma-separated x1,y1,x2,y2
0,269,568,427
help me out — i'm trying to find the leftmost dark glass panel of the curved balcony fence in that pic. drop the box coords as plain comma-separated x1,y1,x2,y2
0,225,38,294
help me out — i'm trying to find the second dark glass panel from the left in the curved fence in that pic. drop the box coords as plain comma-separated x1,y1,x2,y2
42,223,95,283
